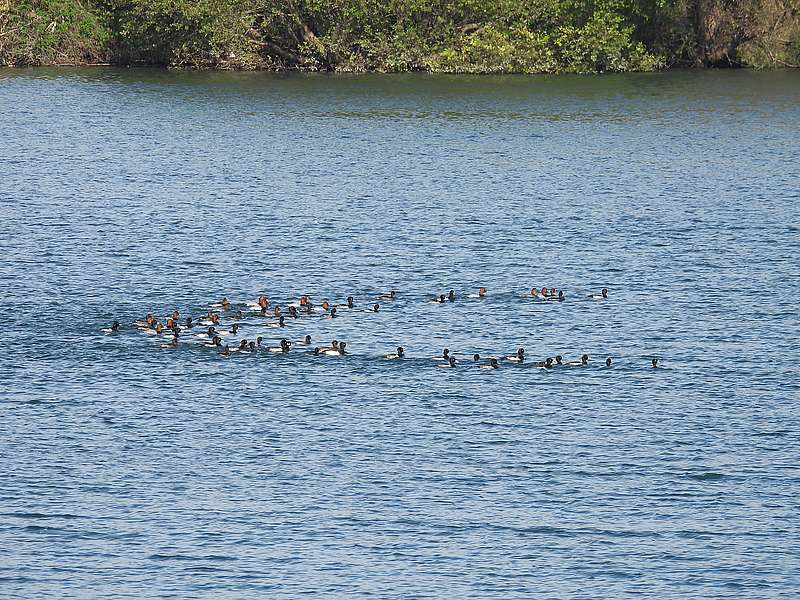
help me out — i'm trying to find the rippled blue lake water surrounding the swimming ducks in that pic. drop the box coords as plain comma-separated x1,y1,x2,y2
0,69,800,598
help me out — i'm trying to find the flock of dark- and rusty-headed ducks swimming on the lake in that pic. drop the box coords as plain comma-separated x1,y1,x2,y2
101,287,658,369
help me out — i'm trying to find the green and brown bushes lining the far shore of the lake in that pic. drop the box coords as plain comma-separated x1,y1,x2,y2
0,0,800,73
